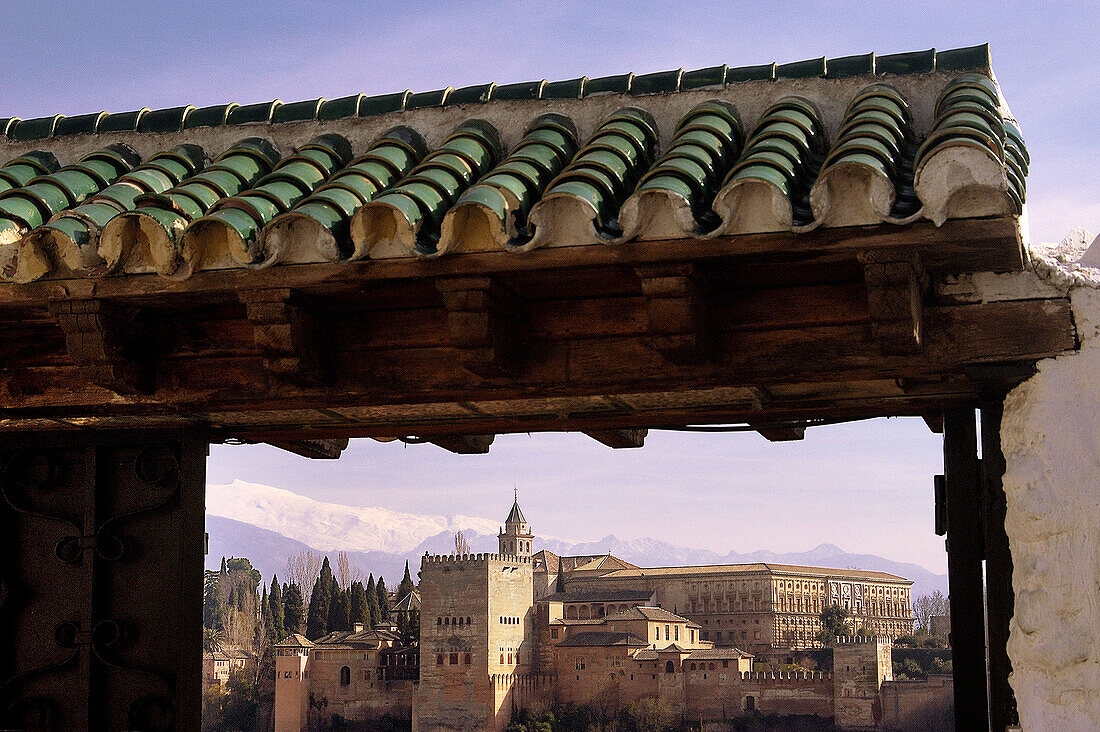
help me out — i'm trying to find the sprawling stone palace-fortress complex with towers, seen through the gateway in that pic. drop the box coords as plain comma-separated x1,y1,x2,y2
275,500,928,732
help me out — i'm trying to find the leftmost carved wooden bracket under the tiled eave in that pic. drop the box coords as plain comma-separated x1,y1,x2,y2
50,299,153,394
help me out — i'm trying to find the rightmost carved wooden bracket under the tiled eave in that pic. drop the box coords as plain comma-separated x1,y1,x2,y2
859,250,927,356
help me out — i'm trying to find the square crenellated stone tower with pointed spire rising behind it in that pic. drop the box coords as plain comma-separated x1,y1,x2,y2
413,493,534,732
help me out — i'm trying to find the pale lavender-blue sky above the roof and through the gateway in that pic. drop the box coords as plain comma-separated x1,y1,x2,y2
0,0,1100,571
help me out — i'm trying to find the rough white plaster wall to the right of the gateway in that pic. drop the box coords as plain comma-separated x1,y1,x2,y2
998,232,1100,730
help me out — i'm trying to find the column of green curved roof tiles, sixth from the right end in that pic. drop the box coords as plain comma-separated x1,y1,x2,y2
436,113,576,254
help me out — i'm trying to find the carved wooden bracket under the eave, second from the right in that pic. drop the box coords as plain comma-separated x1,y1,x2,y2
635,263,712,364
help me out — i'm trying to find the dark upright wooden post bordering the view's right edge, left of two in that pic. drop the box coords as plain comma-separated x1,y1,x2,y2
944,407,989,730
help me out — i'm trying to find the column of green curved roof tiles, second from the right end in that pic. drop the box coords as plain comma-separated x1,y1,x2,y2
810,84,915,227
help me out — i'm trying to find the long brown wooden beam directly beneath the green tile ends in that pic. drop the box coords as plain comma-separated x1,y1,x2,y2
0,217,1025,309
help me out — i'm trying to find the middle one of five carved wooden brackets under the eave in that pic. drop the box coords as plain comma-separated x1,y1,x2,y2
436,277,523,379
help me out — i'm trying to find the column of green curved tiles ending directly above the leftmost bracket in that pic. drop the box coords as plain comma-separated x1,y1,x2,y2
21,144,209,277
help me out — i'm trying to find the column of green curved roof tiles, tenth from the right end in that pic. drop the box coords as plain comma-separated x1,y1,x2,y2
99,136,279,277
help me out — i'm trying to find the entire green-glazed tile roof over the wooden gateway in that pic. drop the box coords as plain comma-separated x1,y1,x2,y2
0,46,1029,283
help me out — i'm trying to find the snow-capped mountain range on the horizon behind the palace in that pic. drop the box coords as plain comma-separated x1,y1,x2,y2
206,481,947,599
